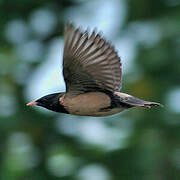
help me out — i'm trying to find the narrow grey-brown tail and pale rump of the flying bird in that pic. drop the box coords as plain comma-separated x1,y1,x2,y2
116,92,163,108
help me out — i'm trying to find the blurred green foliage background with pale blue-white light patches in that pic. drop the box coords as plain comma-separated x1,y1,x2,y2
0,0,180,180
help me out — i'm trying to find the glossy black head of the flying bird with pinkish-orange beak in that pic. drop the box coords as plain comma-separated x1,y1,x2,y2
27,93,68,113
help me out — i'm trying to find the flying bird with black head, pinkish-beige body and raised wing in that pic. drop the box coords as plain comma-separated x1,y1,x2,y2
27,24,161,116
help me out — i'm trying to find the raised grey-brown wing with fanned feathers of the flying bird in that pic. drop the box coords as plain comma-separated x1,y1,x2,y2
63,24,121,93
